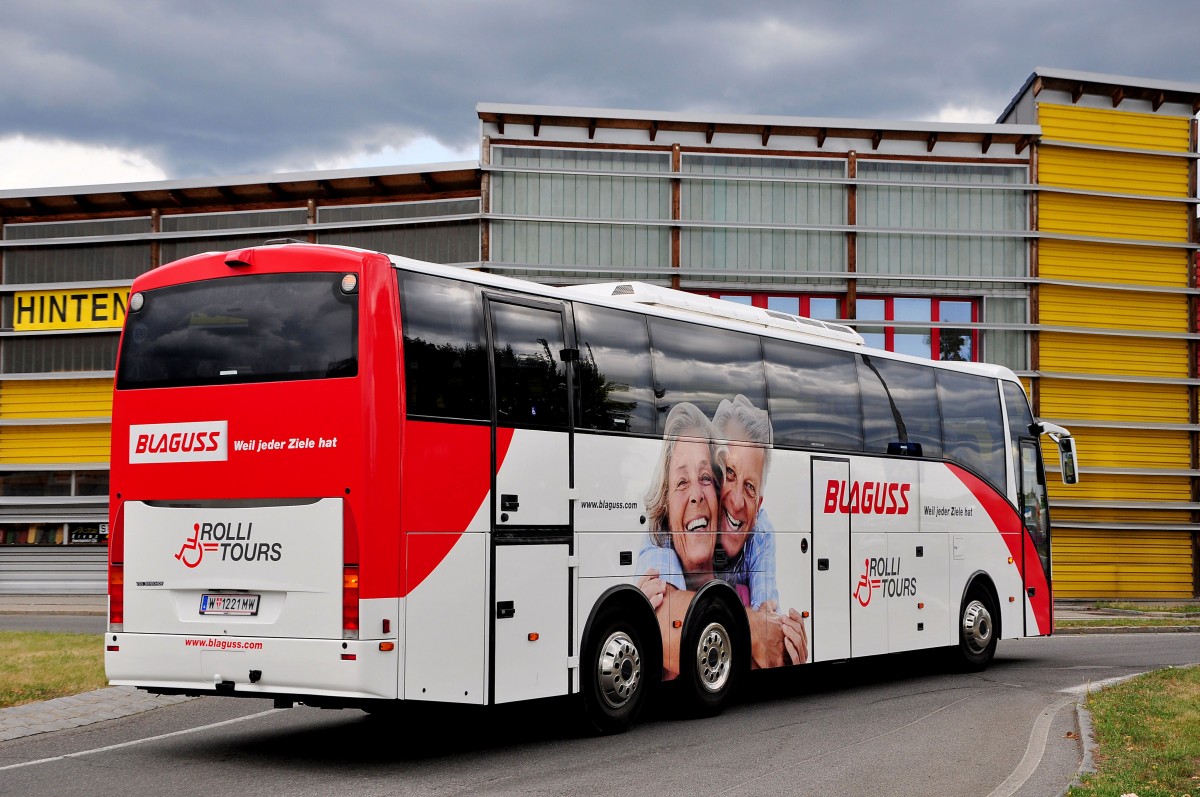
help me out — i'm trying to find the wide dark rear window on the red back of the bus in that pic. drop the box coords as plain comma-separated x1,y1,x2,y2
116,272,359,389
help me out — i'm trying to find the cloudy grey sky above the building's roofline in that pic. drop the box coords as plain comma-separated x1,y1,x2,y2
0,0,1200,190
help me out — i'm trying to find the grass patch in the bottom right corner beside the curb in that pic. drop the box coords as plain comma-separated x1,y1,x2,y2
1067,667,1200,797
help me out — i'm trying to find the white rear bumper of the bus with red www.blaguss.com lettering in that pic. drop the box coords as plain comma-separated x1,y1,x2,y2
104,631,402,701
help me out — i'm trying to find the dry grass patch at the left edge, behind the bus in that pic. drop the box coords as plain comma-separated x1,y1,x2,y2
0,631,108,708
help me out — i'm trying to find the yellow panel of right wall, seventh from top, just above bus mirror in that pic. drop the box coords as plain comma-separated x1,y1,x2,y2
1038,377,1188,422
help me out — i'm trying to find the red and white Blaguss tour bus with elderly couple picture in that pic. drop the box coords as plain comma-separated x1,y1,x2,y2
106,242,1076,731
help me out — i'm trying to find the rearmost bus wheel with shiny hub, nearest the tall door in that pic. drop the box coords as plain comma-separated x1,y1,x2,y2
582,609,653,733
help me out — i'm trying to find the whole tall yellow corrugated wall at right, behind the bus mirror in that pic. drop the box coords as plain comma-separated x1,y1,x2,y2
1034,102,1195,599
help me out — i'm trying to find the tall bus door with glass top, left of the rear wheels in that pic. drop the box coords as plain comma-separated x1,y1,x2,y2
486,295,575,703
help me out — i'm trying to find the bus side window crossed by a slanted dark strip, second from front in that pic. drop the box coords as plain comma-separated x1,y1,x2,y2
858,354,942,457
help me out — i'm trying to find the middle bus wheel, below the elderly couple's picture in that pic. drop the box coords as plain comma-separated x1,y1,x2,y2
679,600,740,717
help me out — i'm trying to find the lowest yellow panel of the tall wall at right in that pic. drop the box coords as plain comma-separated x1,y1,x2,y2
1051,529,1193,599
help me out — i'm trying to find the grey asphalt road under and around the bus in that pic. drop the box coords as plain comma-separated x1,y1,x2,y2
0,634,1200,797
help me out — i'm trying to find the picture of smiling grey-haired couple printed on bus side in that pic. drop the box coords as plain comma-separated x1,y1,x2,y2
637,395,809,678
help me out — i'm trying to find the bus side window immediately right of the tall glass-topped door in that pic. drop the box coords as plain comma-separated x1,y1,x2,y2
575,302,654,435
